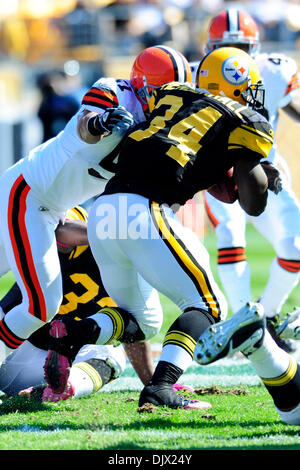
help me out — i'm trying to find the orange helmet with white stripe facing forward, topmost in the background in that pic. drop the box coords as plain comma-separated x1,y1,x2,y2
206,8,260,57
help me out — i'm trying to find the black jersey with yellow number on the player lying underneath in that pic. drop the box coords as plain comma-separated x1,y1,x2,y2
29,245,116,349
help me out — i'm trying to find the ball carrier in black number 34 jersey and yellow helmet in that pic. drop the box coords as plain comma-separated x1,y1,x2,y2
44,48,273,408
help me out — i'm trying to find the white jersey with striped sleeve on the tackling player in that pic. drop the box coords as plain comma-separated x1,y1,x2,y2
18,78,145,211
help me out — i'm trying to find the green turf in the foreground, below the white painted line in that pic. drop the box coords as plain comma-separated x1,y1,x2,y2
0,386,300,450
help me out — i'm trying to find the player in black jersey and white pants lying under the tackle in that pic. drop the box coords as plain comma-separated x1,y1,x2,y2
0,206,196,402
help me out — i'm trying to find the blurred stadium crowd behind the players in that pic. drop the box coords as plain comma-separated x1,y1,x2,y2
0,0,300,197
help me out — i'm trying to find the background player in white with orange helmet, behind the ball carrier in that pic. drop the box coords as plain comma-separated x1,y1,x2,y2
193,8,300,351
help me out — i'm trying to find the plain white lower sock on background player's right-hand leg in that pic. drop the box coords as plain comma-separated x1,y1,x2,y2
260,258,300,317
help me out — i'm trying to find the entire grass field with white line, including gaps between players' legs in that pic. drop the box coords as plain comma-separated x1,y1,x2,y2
0,227,300,452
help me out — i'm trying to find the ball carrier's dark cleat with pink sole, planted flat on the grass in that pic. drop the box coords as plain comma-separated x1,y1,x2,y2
139,383,212,410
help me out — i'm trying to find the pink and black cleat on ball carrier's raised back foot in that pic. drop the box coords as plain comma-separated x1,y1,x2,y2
44,320,71,394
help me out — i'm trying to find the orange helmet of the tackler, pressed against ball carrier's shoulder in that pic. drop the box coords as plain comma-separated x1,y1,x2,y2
130,46,192,111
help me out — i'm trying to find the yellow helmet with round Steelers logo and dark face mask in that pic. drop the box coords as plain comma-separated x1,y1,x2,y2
195,47,265,111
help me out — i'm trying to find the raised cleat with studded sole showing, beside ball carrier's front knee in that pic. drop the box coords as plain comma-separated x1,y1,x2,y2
194,302,265,365
